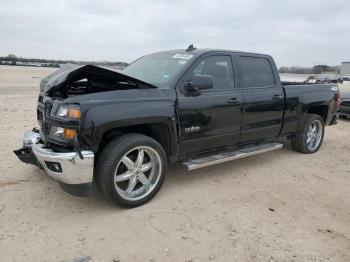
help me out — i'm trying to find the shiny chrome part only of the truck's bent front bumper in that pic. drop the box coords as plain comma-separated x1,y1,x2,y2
23,131,94,185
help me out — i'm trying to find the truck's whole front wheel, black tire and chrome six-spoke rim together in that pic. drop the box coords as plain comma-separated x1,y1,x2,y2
96,134,166,207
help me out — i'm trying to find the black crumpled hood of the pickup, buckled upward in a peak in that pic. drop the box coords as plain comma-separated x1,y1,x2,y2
40,64,156,93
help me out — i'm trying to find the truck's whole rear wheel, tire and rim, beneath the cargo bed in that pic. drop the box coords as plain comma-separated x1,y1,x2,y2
292,114,324,154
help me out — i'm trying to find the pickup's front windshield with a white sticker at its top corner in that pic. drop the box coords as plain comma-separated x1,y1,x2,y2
122,53,193,88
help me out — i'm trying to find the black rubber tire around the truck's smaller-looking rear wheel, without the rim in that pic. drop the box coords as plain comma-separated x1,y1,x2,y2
291,114,325,154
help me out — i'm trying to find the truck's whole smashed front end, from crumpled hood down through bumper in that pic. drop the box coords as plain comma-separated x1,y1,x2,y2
14,65,154,196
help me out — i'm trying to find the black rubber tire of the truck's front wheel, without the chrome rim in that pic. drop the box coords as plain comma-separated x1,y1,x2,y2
96,134,167,208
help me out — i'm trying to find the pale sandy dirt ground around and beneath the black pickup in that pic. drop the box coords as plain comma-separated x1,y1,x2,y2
0,66,350,262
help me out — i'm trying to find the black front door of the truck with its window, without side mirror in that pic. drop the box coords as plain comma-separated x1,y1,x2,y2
177,53,242,155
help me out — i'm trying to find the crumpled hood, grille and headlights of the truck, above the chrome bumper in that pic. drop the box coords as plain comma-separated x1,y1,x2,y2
37,65,155,149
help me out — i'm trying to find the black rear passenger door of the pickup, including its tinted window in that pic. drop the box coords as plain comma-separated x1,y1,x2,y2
237,55,284,143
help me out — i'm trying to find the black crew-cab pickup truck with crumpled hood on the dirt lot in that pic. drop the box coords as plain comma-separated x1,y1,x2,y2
15,47,340,207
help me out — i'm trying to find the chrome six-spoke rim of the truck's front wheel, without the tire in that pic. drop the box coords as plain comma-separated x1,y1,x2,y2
114,146,162,201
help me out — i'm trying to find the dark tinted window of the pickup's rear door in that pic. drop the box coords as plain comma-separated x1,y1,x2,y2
238,56,275,88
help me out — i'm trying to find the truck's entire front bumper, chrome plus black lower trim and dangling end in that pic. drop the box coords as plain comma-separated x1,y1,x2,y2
15,131,95,195
